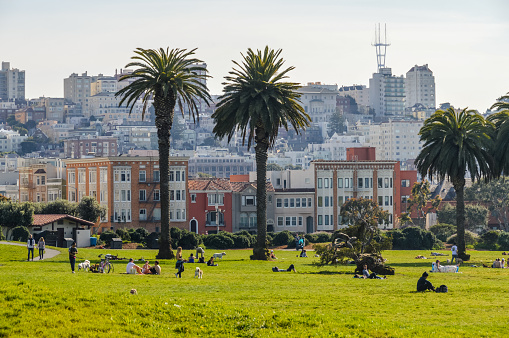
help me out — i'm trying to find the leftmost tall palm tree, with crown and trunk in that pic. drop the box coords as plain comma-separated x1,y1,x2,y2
116,48,211,259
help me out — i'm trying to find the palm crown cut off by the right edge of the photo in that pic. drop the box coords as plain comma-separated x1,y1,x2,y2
488,93,509,177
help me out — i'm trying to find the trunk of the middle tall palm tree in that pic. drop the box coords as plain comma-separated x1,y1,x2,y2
251,127,269,260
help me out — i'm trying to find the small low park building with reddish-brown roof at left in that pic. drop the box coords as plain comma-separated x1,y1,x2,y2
28,214,94,247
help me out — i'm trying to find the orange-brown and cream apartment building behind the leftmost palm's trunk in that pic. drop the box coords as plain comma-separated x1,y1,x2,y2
65,156,189,232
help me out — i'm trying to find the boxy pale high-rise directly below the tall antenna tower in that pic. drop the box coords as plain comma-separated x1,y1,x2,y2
369,68,405,116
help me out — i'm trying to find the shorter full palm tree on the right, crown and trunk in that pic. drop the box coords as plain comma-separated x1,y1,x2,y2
415,108,493,260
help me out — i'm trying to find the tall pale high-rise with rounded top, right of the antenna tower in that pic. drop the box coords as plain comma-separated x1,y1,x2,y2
405,64,436,109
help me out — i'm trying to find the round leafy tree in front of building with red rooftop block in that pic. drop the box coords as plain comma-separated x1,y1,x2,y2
340,197,389,254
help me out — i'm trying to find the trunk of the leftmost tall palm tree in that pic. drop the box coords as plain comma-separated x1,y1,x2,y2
154,94,175,259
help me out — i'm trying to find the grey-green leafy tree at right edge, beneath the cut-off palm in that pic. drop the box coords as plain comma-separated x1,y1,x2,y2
465,177,509,231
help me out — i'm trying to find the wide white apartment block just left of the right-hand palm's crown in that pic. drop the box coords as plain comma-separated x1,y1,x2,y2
367,120,423,161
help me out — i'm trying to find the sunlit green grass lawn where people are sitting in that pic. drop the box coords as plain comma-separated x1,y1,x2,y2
0,245,509,337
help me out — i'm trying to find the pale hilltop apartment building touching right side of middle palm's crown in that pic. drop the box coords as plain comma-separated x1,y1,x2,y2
298,83,338,123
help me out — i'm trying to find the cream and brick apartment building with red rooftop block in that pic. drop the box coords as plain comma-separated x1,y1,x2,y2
313,148,417,231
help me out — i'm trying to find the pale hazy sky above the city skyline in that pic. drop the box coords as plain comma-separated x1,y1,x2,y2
0,0,509,112
